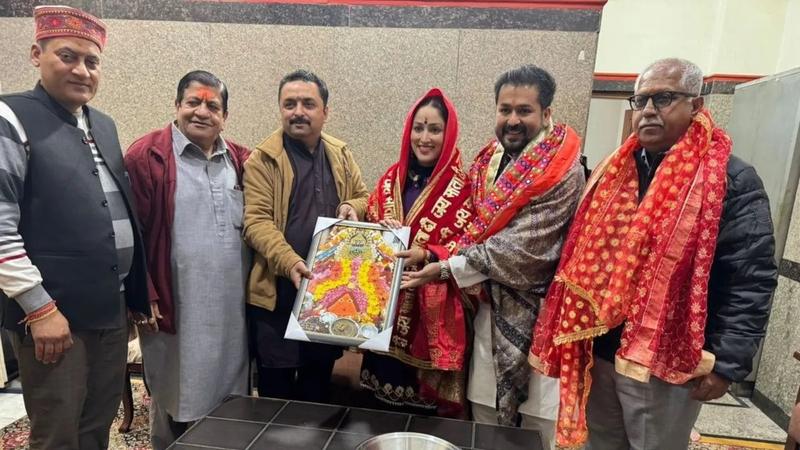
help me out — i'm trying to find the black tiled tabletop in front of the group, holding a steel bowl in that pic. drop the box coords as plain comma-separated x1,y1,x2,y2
176,397,542,450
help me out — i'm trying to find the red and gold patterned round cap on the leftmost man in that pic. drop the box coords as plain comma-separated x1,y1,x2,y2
33,6,106,51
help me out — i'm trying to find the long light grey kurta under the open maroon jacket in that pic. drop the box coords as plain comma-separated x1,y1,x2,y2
141,126,250,422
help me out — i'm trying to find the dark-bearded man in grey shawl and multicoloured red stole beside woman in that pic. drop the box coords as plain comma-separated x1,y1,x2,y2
409,66,584,448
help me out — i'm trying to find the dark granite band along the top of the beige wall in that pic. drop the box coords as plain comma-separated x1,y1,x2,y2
0,0,600,31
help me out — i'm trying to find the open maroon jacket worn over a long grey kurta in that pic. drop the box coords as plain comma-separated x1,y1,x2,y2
125,124,250,334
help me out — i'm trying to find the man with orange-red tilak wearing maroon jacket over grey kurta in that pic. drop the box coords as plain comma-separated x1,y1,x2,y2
125,70,250,450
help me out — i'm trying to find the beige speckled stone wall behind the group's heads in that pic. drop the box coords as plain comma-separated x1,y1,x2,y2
0,18,597,184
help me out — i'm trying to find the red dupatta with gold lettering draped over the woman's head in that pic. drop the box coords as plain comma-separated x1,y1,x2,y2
367,88,473,370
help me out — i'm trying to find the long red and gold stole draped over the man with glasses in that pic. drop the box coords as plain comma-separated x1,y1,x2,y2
529,110,731,447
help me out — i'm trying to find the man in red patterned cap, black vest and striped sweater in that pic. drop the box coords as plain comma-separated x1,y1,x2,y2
0,6,151,449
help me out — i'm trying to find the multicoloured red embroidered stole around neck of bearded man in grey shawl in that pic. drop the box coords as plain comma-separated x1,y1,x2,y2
459,124,581,247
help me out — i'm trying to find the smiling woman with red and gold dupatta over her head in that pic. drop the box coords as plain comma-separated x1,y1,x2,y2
361,88,473,417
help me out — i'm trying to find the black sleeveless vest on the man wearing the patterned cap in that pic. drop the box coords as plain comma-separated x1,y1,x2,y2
2,84,149,330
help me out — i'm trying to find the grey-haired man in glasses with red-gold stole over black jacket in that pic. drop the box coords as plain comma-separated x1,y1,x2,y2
530,59,776,450
